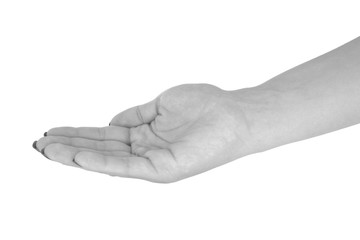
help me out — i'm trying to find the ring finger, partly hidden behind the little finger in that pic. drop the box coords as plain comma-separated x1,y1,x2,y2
42,143,131,167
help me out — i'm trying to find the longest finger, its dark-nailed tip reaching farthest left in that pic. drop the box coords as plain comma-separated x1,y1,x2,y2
36,136,130,152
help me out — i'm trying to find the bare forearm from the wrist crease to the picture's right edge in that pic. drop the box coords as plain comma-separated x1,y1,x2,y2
235,38,360,154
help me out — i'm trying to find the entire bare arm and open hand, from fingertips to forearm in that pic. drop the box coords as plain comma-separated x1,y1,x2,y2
33,38,360,183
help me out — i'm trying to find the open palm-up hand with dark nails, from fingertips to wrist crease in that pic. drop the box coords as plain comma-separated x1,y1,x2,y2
34,84,250,182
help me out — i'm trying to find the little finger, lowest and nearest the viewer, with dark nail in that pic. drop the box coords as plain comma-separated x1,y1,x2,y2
74,152,158,181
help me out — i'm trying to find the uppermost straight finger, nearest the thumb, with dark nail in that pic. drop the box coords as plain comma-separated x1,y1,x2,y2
46,126,130,144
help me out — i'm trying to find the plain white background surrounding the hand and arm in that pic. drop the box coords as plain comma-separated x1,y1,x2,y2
0,0,360,240
